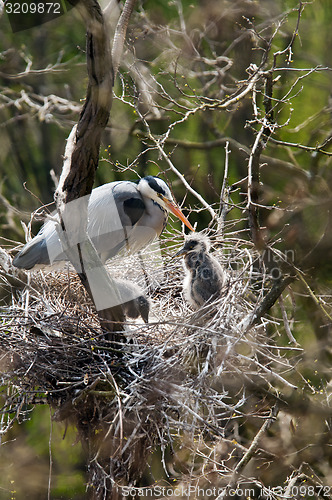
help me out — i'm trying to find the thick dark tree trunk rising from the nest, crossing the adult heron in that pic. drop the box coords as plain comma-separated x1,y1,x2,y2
55,0,123,340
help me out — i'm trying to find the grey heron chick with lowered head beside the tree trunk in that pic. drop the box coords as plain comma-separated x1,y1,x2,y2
114,279,150,323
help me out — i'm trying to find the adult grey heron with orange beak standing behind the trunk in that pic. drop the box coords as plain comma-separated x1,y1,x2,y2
13,176,193,270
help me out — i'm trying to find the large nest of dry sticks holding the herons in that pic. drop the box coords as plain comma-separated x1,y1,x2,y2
0,229,299,494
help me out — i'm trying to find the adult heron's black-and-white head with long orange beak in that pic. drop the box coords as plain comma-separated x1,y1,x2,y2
138,175,195,231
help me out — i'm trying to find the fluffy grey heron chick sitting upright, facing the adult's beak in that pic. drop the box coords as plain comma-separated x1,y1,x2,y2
175,233,227,309
